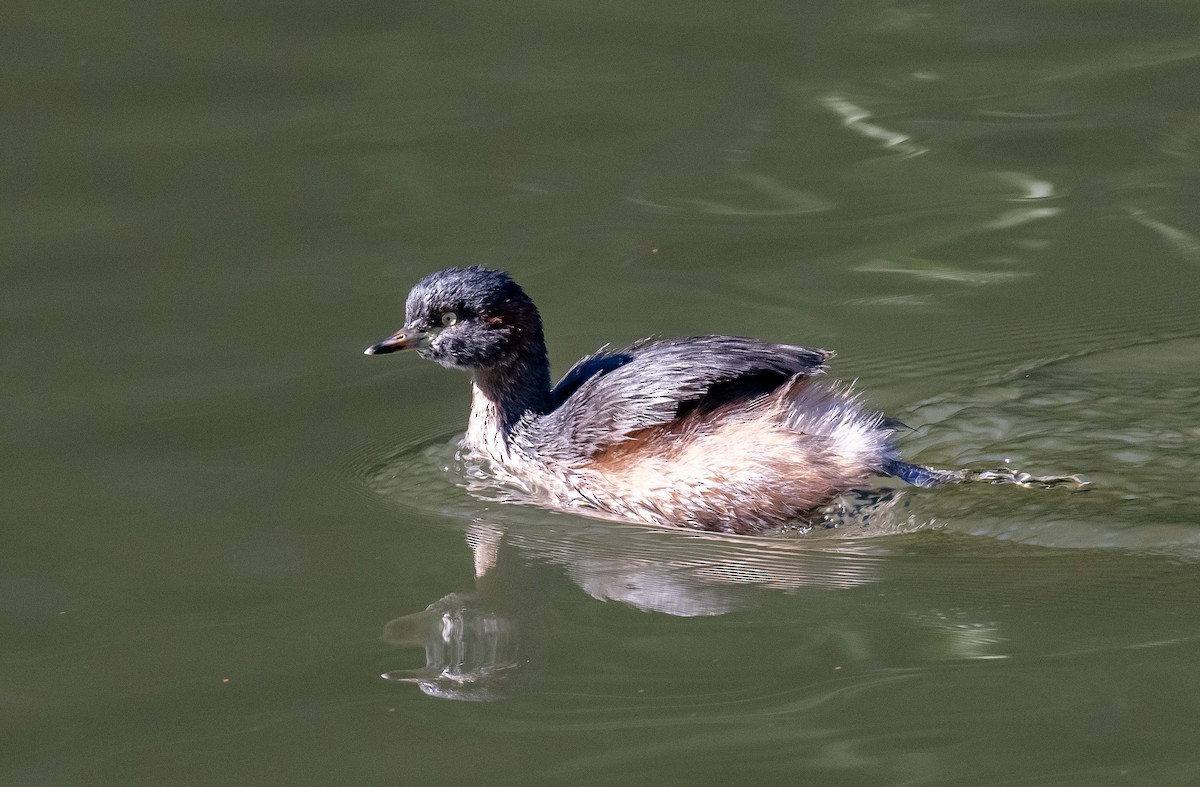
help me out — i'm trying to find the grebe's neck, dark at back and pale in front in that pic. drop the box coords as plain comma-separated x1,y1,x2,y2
467,344,550,455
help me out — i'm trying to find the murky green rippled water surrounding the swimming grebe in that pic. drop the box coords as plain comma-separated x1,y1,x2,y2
7,0,1200,785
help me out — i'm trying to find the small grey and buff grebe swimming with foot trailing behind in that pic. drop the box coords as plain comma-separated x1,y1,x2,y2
366,265,965,534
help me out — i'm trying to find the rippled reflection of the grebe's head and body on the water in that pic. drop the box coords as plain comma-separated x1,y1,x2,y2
382,495,916,702
